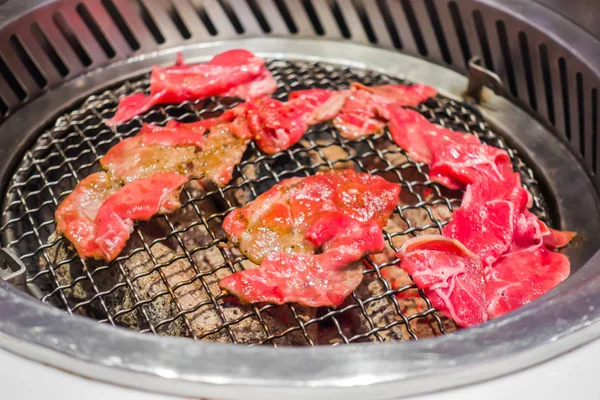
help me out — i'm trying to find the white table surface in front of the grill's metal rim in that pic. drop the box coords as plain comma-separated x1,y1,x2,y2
0,340,600,400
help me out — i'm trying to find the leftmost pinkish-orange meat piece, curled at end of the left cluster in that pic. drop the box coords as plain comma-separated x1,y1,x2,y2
55,172,116,258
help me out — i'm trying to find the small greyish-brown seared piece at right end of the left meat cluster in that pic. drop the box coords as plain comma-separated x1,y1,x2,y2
194,123,250,187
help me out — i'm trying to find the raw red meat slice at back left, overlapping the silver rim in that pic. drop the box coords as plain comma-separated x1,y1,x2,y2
107,50,276,125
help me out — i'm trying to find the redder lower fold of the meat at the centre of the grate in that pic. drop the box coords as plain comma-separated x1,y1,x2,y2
219,214,384,307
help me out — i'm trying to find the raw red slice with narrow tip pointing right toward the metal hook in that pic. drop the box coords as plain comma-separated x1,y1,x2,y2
334,82,436,139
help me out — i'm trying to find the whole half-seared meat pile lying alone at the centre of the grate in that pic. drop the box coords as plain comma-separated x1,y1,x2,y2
220,170,400,306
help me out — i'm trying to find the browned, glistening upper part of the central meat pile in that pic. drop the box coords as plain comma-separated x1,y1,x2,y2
223,170,400,264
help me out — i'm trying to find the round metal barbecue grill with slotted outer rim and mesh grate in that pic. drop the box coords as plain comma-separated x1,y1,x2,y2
0,0,600,398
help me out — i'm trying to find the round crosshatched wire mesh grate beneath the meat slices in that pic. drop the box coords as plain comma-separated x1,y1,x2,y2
0,60,548,346
